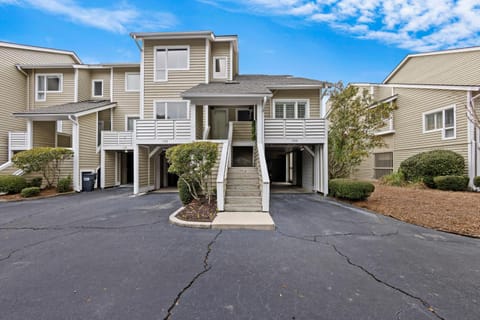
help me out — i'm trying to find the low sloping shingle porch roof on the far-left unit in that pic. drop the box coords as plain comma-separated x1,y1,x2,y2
14,100,116,115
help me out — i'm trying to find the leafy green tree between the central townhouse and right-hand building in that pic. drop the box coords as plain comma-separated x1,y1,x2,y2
328,82,396,179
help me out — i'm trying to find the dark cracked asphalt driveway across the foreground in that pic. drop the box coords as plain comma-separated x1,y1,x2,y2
0,189,480,320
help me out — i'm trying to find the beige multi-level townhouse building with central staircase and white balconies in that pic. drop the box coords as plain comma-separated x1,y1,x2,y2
0,32,328,211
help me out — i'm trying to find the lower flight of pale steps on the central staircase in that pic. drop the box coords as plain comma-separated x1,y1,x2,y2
225,167,262,212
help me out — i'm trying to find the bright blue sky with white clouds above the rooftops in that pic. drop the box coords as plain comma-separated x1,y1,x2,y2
0,0,480,83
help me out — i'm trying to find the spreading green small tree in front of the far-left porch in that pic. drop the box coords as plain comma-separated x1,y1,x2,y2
12,147,73,188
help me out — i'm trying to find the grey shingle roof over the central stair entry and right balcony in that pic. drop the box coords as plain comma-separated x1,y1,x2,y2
182,74,328,98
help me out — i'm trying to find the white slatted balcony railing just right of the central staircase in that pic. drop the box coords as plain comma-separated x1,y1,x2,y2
264,118,327,143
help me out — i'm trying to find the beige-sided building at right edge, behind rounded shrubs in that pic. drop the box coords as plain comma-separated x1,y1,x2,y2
353,47,480,184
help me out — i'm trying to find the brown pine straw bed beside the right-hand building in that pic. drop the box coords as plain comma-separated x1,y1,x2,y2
352,184,480,238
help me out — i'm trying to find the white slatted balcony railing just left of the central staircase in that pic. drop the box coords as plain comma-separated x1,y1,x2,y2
135,120,192,143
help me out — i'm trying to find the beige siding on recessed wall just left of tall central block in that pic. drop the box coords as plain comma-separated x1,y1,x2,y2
113,67,140,131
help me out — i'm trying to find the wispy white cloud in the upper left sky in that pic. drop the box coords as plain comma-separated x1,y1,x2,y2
0,0,177,33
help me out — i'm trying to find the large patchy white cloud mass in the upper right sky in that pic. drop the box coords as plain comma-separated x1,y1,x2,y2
205,0,480,51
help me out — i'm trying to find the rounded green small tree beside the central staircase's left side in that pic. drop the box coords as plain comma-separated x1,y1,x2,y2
166,142,218,202
